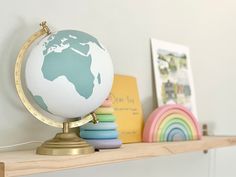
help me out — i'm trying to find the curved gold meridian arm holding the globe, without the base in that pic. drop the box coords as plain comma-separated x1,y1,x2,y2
15,22,95,128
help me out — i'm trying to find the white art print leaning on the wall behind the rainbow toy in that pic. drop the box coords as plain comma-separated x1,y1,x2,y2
151,39,197,117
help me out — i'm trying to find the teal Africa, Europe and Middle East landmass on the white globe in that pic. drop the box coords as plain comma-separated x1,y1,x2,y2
41,30,104,99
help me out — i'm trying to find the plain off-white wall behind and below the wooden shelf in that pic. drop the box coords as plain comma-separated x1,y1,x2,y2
0,0,236,177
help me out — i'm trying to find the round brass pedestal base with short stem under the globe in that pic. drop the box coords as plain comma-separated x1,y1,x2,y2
36,122,94,155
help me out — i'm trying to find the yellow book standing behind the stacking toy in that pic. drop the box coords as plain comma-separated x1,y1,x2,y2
111,75,144,143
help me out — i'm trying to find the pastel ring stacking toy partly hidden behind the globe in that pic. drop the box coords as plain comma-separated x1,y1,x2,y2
80,97,122,149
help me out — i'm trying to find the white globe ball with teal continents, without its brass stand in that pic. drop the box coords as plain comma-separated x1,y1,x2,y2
25,30,114,118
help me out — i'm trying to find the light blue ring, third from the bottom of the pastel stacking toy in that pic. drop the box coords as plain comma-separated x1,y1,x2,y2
80,122,117,130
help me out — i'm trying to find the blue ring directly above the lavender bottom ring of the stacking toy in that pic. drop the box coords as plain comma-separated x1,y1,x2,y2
80,130,118,139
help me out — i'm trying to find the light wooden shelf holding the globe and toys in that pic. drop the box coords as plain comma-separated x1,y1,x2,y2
0,136,236,177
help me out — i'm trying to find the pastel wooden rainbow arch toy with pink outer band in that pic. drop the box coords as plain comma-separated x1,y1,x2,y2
143,105,202,142
